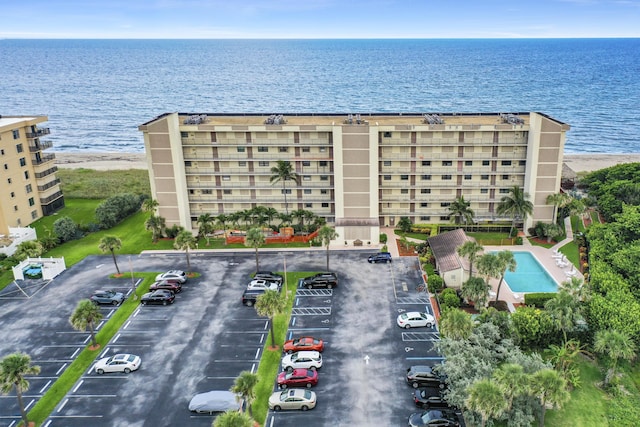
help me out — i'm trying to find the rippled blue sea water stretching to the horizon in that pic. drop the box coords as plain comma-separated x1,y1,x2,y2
0,39,640,153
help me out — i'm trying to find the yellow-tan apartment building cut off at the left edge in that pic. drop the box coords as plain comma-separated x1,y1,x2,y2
0,116,64,236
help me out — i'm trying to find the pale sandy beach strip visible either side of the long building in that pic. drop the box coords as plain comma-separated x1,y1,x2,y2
55,152,640,173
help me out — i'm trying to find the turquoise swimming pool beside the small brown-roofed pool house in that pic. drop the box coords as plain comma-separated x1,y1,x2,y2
504,252,558,292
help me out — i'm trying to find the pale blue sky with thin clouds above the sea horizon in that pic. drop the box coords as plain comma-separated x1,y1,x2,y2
0,0,640,39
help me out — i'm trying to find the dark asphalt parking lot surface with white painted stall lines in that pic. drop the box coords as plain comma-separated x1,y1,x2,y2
0,251,439,426
